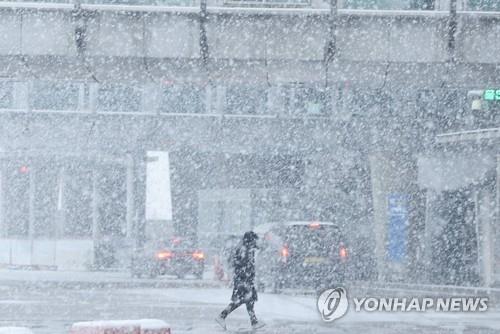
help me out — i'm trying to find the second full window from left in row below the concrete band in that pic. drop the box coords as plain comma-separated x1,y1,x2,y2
97,84,142,112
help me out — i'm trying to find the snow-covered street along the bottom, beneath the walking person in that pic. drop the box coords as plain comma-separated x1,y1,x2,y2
0,271,500,334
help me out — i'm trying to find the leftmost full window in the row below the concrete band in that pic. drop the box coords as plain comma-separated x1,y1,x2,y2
31,81,80,110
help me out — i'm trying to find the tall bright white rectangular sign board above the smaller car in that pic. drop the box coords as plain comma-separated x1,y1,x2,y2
146,151,172,220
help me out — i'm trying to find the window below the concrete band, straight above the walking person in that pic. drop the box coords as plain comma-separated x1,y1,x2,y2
224,85,267,115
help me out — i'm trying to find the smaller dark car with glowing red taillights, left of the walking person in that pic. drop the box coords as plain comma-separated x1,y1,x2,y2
132,238,205,279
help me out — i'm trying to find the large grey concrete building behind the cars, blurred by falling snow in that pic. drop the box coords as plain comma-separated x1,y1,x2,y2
0,0,500,286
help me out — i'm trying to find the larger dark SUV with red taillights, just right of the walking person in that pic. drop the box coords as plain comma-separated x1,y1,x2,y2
255,222,348,291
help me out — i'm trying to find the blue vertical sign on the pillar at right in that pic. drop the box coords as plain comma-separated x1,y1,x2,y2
387,194,408,262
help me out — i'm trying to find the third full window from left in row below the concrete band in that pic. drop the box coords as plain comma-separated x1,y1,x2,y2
160,84,205,114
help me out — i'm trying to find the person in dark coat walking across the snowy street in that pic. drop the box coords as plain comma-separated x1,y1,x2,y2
215,231,264,330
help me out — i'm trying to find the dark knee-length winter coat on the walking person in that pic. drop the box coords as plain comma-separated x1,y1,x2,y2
231,243,257,303
